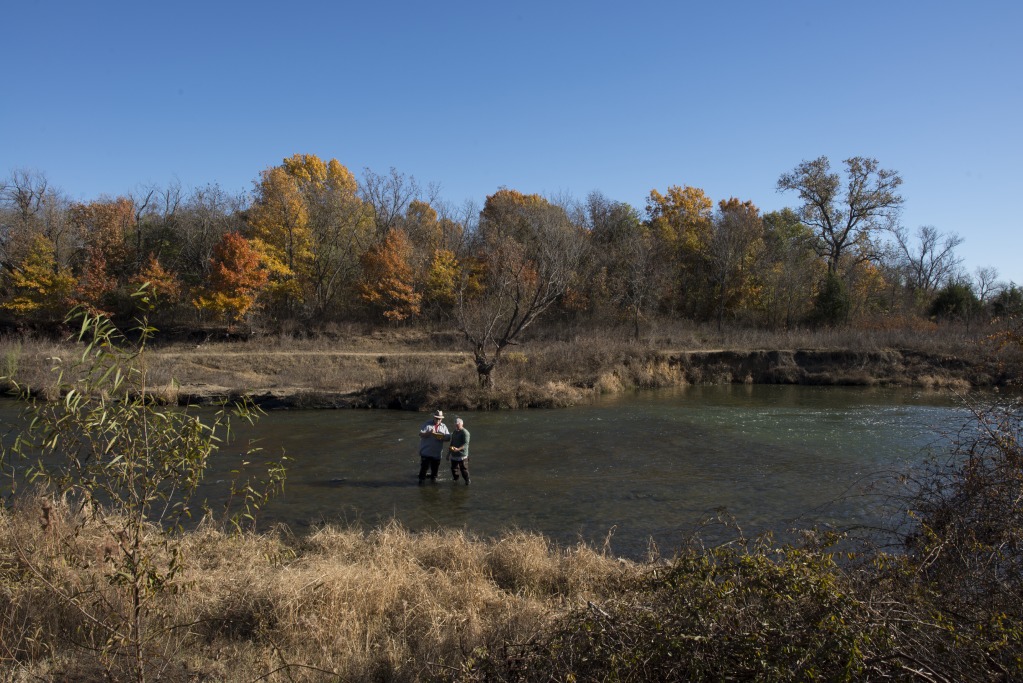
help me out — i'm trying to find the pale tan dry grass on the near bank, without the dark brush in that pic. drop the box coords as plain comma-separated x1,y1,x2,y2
0,498,642,681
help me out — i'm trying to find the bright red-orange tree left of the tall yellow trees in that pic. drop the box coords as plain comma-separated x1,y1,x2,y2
192,232,268,325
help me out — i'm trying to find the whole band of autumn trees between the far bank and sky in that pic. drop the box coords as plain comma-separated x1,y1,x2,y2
0,154,1021,368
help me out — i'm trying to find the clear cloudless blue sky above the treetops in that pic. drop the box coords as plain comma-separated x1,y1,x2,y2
0,0,1023,283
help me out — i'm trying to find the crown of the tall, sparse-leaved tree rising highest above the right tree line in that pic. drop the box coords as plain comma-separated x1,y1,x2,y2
777,156,902,274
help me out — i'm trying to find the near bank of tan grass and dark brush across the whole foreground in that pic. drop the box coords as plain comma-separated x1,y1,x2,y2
0,484,1023,682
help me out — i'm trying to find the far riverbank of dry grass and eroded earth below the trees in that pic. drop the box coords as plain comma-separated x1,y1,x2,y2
0,321,1023,411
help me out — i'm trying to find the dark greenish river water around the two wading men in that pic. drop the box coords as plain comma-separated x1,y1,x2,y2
0,385,967,558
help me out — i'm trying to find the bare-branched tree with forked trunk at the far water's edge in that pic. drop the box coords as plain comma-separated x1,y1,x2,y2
454,189,582,386
